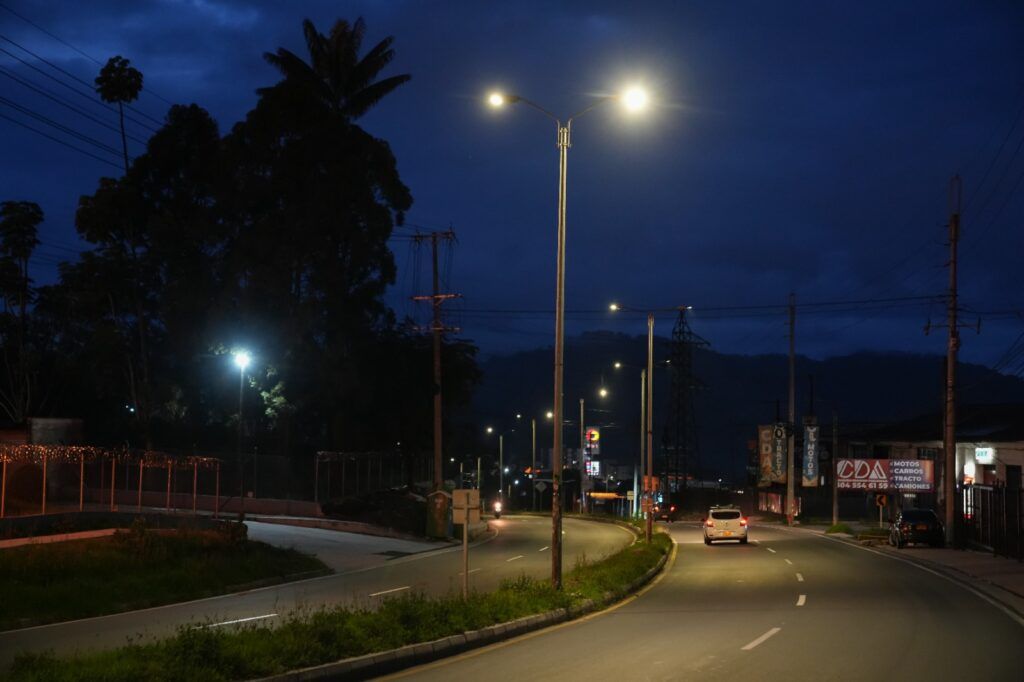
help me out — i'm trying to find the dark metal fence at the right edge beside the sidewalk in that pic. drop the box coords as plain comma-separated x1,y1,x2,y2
964,485,1024,561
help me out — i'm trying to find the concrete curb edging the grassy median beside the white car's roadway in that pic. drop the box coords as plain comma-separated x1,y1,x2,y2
257,532,672,682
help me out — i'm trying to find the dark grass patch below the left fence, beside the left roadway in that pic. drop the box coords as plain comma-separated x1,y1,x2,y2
0,522,325,630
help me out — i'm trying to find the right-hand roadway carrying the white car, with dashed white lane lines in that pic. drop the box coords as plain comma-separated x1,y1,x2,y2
388,524,1024,682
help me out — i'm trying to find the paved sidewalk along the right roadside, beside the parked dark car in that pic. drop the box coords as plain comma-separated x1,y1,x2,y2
794,524,1024,623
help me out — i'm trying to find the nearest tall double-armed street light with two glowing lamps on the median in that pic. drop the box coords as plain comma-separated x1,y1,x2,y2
487,87,648,590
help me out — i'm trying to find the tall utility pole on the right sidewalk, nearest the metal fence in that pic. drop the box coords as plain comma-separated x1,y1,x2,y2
942,175,961,546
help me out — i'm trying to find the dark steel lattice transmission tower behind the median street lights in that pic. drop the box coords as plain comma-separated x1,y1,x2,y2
666,307,709,499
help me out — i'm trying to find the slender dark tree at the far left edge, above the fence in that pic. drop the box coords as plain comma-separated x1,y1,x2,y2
0,202,43,424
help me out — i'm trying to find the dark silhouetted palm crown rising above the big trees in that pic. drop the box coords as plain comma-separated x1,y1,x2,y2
257,17,412,121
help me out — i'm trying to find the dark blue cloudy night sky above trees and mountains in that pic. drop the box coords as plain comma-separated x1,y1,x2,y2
0,0,1024,369
